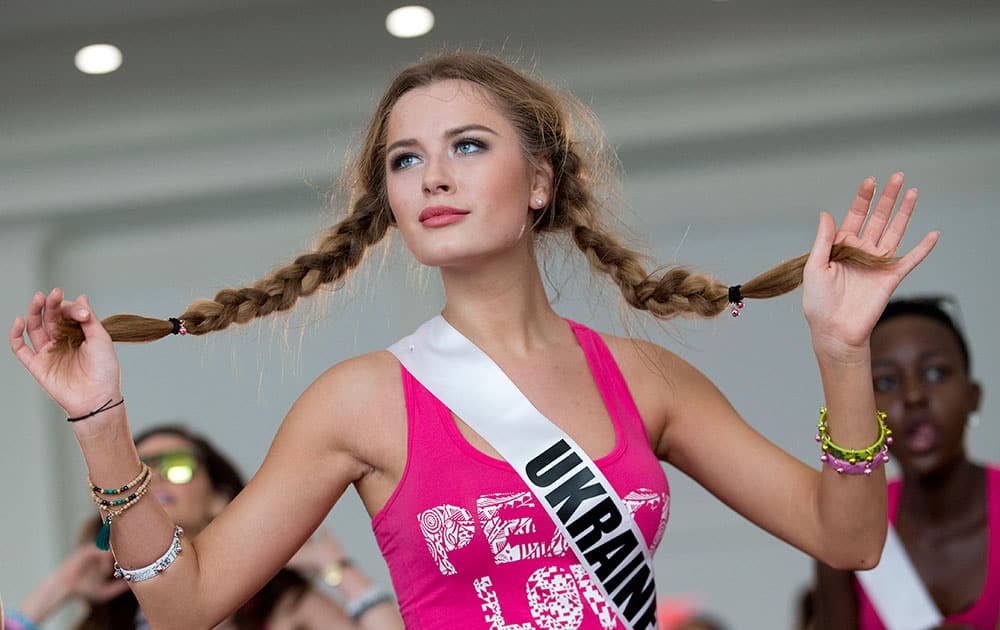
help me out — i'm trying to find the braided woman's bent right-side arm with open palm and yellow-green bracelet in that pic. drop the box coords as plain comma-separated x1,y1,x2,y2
628,173,937,569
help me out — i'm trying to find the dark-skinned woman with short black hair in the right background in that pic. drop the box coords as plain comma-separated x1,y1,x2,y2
816,299,1000,630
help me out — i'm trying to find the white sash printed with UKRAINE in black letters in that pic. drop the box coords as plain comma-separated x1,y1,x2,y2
389,316,656,630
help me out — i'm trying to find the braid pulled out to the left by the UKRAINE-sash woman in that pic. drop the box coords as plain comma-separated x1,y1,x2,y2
54,193,389,352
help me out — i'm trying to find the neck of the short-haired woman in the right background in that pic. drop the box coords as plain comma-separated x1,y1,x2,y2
899,457,985,522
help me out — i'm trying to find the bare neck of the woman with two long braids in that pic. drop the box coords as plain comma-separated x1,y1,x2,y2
441,246,566,355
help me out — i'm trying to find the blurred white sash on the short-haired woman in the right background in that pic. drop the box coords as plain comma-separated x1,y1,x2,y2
854,525,944,630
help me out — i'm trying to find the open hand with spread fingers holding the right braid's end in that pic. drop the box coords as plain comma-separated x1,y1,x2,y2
802,173,939,362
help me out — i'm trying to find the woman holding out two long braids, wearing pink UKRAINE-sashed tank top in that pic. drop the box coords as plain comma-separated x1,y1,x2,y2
10,53,937,629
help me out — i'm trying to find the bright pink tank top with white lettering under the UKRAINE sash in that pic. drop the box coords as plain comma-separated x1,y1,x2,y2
372,322,670,630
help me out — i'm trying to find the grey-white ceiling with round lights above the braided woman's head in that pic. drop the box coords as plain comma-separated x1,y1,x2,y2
0,0,1000,221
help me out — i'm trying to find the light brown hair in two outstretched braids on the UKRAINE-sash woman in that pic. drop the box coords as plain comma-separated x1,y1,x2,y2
55,52,892,351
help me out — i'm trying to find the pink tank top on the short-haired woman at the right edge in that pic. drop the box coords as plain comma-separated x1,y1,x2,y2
855,467,1000,630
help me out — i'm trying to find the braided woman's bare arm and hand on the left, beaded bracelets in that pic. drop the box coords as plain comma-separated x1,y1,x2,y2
10,289,381,628
